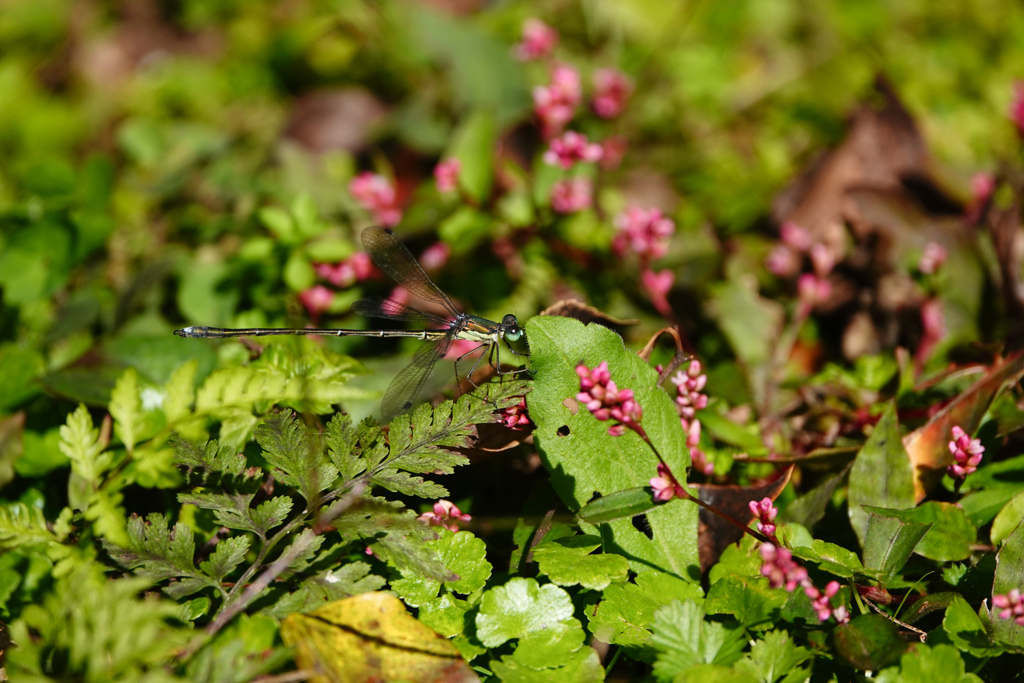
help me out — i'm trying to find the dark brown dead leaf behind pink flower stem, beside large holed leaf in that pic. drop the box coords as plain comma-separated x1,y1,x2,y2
689,465,794,571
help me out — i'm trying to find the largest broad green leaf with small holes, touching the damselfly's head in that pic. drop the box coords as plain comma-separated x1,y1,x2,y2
526,316,700,581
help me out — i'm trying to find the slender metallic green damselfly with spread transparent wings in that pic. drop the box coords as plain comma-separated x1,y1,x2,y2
174,227,529,420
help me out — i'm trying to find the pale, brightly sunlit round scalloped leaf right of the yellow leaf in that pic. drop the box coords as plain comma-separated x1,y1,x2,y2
476,578,572,647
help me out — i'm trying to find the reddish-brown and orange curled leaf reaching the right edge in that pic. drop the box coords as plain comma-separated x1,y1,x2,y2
903,351,1024,503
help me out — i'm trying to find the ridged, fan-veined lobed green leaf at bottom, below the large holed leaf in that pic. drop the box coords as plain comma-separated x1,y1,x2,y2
651,600,745,681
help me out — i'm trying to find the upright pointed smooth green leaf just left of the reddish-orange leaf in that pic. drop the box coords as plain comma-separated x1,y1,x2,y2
849,402,916,546
